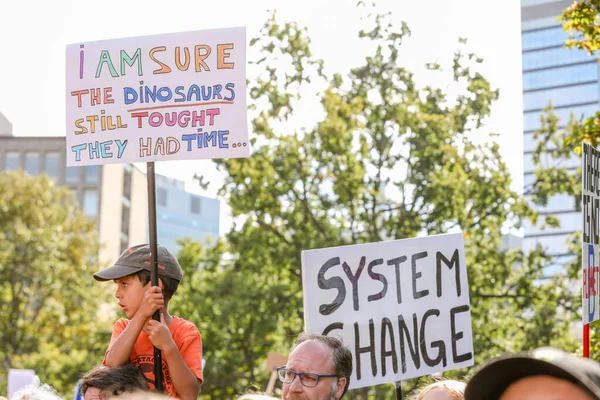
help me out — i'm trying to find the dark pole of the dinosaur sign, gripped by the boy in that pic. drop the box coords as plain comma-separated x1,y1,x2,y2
146,161,165,393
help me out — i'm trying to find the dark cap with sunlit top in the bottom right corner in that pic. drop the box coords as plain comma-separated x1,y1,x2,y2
465,347,600,400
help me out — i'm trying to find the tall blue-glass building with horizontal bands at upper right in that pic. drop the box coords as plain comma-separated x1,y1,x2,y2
521,0,600,272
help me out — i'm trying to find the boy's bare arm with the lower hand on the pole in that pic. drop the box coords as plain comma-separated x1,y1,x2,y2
144,320,200,400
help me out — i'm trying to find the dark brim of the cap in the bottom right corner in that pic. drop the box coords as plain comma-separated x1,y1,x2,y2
465,356,597,400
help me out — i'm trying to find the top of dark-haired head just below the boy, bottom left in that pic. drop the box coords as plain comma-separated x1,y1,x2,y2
79,364,148,400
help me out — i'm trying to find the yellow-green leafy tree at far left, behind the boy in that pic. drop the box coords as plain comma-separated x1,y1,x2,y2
0,172,110,396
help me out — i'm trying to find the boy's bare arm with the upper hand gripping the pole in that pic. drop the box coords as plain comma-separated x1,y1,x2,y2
104,286,164,367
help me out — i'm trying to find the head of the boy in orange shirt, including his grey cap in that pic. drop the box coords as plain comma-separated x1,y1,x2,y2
94,244,183,318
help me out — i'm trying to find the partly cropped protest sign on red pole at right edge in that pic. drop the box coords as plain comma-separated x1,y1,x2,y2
581,142,600,324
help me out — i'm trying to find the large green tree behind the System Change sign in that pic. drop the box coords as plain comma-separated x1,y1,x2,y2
177,9,576,399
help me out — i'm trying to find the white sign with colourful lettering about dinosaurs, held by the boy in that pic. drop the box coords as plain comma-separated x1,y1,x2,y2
66,28,250,166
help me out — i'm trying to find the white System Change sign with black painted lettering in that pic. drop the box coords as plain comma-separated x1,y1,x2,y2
302,233,473,389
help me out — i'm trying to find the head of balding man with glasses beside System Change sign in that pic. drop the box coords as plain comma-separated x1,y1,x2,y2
278,334,352,400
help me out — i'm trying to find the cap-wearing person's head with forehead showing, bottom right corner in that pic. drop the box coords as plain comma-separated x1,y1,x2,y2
465,347,600,400
